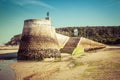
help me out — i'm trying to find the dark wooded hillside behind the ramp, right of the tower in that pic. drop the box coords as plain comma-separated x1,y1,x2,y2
56,26,120,44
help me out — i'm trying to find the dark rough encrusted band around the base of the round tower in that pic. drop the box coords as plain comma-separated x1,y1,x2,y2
18,49,61,60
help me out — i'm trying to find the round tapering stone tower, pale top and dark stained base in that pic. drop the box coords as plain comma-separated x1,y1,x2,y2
18,18,61,60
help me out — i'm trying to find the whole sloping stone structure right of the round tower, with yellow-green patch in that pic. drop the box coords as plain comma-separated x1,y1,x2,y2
56,33,106,54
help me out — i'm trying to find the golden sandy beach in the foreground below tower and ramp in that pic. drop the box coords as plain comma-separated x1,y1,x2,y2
2,46,120,80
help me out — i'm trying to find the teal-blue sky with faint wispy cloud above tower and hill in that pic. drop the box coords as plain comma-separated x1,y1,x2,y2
0,0,120,44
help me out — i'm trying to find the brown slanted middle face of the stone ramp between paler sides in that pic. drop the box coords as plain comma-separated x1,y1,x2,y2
60,37,80,53
